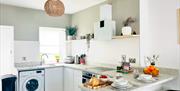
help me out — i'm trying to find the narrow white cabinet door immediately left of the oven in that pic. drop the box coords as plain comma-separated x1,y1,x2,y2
74,70,82,91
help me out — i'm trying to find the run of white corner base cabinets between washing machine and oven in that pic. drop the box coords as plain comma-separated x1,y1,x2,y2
45,67,82,91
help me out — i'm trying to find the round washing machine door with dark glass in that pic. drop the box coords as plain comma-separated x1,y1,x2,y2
23,77,44,91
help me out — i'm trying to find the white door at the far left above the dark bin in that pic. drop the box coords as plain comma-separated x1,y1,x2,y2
0,26,15,75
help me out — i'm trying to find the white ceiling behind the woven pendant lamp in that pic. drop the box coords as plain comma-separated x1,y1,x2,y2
0,0,106,14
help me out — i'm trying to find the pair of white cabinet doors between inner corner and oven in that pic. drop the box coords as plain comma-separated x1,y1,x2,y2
64,67,82,91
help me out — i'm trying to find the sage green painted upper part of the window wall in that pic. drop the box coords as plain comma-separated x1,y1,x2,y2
0,4,71,41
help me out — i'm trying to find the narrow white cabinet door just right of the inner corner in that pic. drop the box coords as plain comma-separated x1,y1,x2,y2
64,68,74,91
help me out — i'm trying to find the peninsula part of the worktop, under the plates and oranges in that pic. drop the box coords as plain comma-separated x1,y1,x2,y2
80,72,176,91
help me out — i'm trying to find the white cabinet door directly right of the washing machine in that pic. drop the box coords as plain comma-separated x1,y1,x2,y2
45,67,63,91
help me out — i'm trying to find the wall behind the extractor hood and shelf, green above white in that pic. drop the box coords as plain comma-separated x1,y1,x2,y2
72,0,139,66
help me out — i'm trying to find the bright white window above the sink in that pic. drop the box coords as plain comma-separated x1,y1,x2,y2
39,27,66,64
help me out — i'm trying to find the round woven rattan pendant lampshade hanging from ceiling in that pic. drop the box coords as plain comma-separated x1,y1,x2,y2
44,0,65,16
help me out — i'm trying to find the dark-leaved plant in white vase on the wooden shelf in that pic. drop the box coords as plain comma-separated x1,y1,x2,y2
121,17,135,35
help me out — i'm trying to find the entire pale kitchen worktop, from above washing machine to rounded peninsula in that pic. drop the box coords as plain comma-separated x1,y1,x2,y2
17,63,178,91
